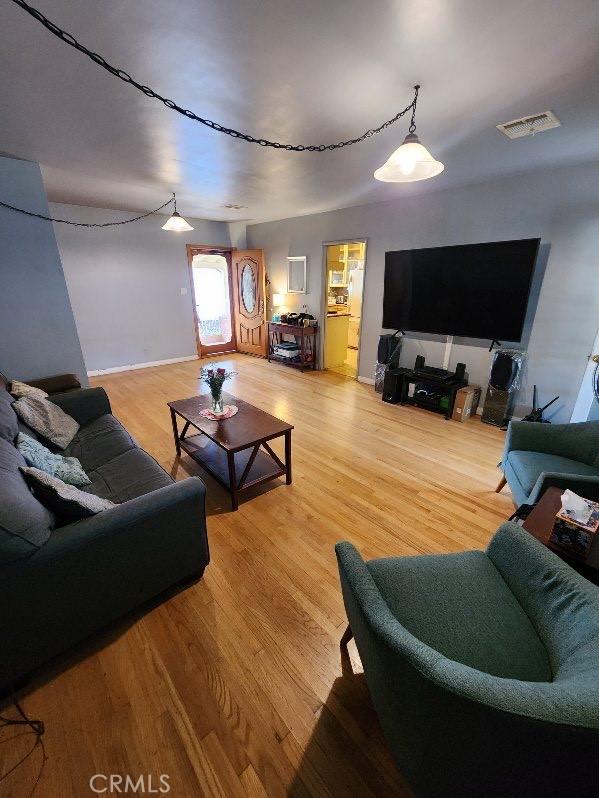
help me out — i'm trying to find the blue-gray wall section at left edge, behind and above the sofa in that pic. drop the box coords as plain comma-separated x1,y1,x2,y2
0,156,87,384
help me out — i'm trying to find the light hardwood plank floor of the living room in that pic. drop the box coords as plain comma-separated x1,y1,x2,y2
0,355,512,798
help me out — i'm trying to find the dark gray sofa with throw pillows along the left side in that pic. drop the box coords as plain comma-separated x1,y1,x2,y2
0,379,210,698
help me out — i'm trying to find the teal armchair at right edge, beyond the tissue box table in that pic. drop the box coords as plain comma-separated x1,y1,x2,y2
496,421,599,507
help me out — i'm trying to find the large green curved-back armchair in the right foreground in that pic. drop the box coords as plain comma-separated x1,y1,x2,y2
336,523,599,798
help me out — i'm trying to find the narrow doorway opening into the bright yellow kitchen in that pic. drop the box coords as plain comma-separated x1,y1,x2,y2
323,240,366,379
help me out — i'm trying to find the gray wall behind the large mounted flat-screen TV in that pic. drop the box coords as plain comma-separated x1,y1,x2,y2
247,163,599,421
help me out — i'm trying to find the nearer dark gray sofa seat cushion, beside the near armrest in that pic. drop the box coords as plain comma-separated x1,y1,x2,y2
84,448,173,503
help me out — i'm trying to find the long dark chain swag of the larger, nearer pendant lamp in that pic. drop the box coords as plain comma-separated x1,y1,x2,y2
12,0,420,152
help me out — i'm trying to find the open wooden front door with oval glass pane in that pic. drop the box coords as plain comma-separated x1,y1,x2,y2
232,249,268,357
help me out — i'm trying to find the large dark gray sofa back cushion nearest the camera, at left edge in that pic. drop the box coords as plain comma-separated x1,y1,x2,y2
0,438,54,565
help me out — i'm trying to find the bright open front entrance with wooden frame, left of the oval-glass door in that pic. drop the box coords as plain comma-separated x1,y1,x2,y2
187,244,236,357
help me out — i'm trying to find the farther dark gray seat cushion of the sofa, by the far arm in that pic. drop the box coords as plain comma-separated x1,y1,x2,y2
64,414,137,472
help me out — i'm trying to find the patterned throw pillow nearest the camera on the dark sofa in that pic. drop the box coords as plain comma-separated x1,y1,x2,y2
21,467,116,521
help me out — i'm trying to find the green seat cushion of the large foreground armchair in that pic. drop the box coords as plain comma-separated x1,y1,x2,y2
367,551,552,682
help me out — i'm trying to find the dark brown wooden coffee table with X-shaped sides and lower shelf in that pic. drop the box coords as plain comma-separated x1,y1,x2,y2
168,393,293,510
